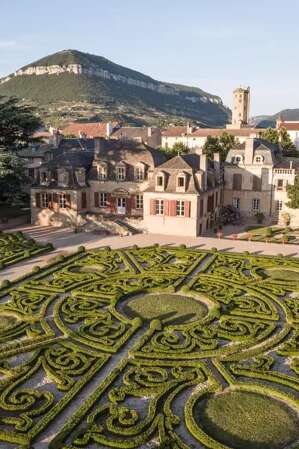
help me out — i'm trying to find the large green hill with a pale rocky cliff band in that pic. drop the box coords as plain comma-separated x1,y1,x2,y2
0,50,230,126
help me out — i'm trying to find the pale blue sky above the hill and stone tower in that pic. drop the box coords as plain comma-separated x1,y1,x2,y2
0,0,299,115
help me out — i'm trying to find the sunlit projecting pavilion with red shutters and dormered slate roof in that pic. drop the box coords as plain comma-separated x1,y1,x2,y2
144,154,223,237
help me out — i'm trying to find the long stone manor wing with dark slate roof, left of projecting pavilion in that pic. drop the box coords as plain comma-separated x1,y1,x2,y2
31,139,165,225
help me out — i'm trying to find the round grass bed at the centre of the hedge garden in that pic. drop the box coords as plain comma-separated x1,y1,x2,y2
124,294,207,324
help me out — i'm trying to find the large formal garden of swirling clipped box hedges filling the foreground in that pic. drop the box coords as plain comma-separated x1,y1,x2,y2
0,246,299,449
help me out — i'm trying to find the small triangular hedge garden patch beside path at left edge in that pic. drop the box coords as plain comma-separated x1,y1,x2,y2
0,231,53,270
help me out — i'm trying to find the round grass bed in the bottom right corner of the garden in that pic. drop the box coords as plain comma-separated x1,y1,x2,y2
194,391,299,449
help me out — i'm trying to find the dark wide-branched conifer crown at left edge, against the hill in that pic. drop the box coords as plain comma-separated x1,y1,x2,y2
0,96,41,151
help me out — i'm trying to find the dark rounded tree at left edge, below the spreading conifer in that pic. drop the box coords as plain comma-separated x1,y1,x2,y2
0,151,26,204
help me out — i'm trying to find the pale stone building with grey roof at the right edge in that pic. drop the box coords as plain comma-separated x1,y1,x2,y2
224,138,299,225
